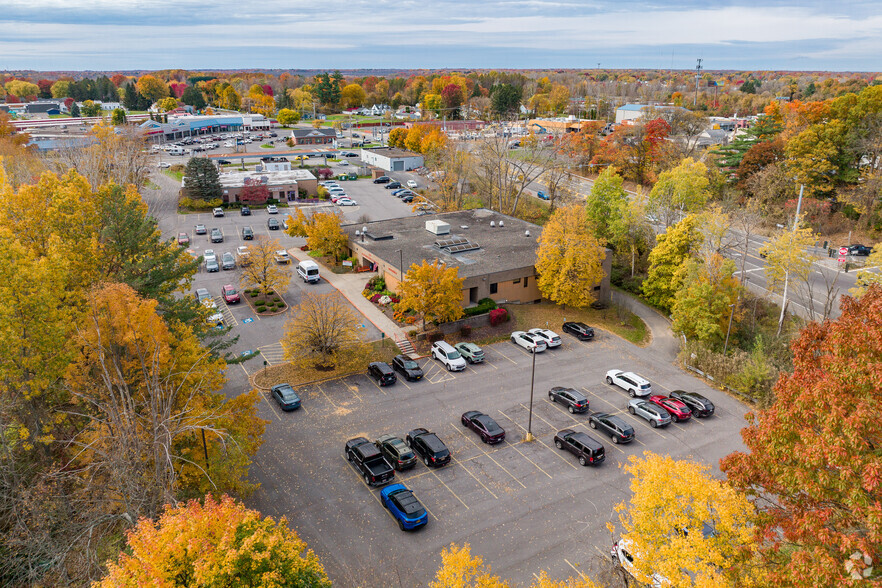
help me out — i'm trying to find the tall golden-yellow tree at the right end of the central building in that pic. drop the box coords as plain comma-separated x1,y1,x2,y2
536,206,606,308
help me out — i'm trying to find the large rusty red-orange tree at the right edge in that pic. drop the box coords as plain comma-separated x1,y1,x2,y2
721,285,882,587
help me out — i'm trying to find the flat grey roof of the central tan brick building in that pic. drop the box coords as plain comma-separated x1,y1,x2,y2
343,208,542,278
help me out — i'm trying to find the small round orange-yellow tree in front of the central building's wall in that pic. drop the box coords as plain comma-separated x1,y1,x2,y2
398,260,463,330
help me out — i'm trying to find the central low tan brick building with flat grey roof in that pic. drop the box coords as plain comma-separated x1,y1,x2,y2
343,208,612,306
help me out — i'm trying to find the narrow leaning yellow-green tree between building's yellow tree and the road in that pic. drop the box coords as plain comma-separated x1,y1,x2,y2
643,215,703,311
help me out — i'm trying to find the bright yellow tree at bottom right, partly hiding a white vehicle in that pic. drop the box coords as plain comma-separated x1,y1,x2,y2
610,451,756,588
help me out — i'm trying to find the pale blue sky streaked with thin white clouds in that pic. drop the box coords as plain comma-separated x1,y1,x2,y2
0,0,882,71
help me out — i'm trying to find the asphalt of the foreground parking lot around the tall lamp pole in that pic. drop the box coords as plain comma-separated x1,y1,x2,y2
244,326,746,586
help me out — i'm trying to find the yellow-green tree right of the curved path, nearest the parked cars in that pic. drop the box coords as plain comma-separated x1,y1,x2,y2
671,253,741,345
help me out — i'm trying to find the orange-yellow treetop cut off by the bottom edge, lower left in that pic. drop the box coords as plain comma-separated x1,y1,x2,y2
95,496,331,588
